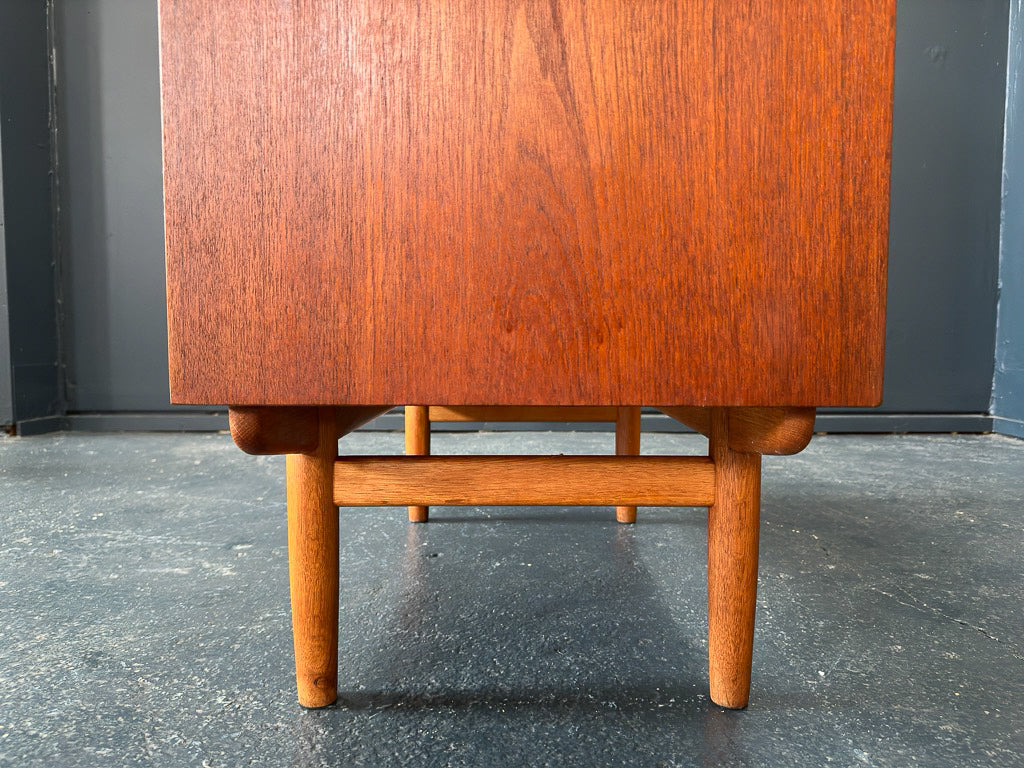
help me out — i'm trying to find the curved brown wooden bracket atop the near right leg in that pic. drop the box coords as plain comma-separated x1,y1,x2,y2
658,406,814,456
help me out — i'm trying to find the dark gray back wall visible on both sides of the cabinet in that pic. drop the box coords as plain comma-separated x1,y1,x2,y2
44,0,1009,430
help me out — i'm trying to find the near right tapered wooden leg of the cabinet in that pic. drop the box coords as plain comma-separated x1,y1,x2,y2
708,409,761,710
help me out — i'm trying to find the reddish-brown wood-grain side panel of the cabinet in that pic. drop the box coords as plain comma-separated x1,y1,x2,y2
161,0,896,406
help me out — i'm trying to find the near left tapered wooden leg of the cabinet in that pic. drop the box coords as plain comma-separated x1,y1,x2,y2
287,408,338,707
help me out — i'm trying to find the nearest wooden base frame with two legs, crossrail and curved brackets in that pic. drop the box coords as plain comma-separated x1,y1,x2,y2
239,407,814,709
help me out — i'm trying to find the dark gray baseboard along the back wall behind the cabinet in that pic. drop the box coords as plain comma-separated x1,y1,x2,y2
16,409,995,437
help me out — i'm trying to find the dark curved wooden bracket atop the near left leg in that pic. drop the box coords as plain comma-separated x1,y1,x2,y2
228,406,391,456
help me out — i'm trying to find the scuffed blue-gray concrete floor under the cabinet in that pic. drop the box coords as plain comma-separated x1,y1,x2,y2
0,432,1024,768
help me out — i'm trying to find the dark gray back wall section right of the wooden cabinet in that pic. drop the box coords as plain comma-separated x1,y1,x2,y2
885,0,1008,414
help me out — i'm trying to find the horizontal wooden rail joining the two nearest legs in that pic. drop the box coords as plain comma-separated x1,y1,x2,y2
334,456,715,507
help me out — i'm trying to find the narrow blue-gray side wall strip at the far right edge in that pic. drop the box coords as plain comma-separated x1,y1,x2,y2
992,0,1024,437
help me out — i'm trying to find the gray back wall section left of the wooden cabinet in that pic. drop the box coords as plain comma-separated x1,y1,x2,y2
55,0,169,411
